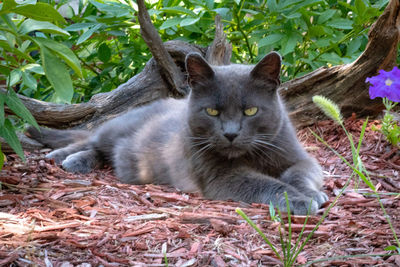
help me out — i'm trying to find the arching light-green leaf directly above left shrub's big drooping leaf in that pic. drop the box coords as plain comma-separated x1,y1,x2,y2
33,38,83,78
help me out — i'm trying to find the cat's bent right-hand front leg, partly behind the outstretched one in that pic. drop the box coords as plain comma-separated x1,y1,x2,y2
280,158,328,206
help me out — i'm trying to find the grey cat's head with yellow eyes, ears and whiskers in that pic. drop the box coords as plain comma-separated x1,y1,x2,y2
186,52,285,158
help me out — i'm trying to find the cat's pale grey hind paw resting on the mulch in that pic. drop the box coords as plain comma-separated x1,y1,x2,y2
62,149,102,173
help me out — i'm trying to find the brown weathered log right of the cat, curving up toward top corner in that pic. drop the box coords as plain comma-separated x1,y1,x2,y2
281,0,400,127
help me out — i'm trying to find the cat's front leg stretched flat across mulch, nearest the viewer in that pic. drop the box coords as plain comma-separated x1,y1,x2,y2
202,169,319,215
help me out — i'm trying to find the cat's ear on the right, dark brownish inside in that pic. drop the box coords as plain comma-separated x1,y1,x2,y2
250,52,282,85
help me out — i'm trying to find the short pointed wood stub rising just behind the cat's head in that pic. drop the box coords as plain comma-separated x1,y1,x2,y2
206,15,232,66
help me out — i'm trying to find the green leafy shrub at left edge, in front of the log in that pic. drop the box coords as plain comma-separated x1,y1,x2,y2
0,0,82,164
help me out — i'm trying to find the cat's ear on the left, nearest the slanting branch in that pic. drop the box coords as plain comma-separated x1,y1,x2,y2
186,53,214,85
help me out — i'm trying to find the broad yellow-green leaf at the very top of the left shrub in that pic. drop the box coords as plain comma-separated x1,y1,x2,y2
12,2,66,23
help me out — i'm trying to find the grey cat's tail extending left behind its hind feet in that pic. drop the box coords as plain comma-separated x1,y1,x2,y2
25,126,90,149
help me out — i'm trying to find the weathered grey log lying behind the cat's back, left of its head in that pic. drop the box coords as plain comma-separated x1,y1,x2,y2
2,41,205,129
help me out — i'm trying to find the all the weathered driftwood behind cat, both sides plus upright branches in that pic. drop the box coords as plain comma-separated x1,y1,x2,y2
3,0,400,150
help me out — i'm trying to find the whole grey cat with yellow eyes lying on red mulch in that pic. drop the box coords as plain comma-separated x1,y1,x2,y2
28,52,327,214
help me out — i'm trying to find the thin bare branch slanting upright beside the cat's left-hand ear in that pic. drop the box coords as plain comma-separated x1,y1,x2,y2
137,0,189,96
